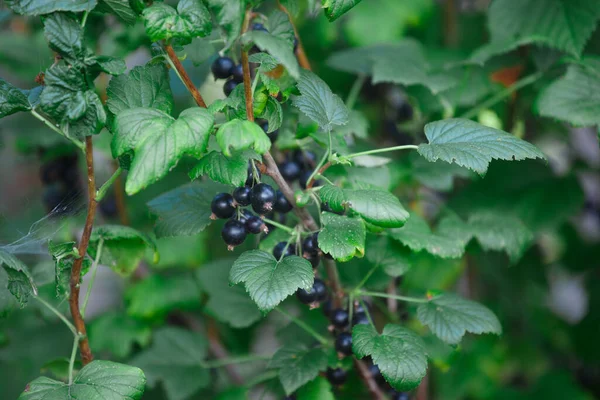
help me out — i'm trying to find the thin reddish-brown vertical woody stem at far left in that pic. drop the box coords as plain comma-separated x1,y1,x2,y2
69,136,97,365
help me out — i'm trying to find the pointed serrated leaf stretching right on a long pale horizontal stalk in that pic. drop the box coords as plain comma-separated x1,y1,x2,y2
418,118,546,175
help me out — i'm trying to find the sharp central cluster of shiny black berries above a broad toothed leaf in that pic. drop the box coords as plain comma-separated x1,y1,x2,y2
210,161,292,250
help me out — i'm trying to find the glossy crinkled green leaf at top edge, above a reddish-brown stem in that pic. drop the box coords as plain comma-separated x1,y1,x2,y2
142,0,212,42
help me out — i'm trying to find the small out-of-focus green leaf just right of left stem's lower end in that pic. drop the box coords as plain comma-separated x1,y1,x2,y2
88,312,152,359
